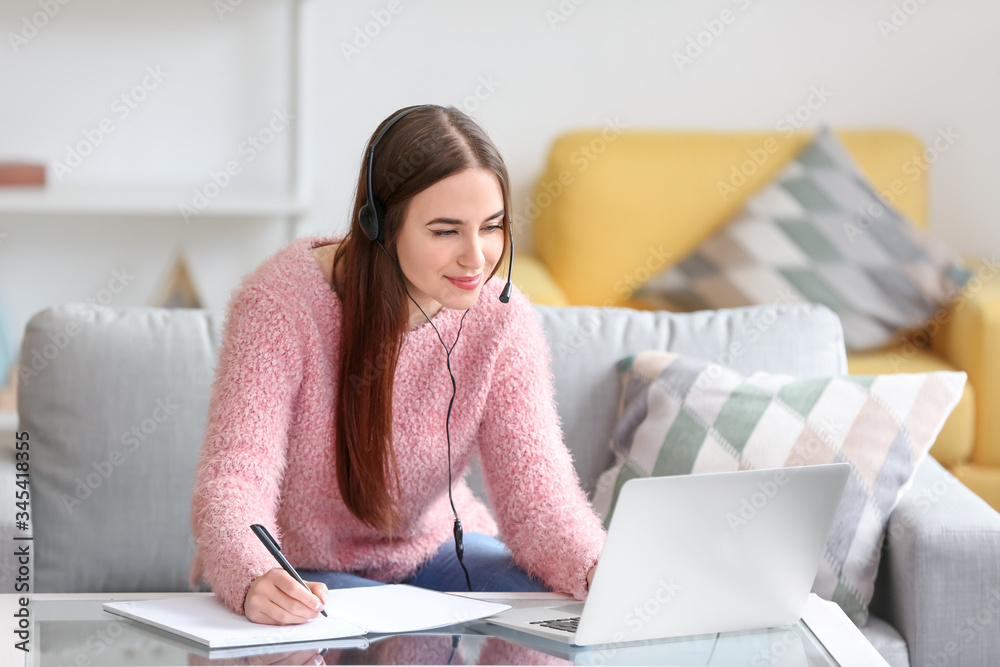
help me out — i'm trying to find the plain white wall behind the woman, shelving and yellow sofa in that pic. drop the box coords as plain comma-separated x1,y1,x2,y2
0,0,1000,360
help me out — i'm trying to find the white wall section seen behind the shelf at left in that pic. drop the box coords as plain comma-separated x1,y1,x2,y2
0,0,289,342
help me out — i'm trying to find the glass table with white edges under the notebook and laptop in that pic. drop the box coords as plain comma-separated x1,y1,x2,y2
0,593,885,667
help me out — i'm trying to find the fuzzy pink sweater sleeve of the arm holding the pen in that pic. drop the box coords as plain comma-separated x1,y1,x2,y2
191,286,302,614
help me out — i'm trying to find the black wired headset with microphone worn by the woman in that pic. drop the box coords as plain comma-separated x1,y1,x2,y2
358,104,514,592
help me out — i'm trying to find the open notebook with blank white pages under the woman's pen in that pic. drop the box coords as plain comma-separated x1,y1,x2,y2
102,584,510,649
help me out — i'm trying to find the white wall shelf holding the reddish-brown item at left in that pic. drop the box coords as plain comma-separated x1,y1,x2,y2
0,185,307,220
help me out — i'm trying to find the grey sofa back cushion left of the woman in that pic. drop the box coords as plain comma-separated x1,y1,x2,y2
18,304,221,593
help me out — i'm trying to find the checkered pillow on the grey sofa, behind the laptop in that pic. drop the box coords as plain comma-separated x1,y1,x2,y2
593,351,966,625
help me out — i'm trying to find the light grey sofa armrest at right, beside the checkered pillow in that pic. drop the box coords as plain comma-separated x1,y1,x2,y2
872,456,1000,667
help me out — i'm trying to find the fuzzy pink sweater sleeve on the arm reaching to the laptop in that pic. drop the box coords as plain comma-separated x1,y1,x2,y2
478,291,605,599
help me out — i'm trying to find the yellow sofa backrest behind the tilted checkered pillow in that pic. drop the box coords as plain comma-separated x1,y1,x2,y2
536,128,927,306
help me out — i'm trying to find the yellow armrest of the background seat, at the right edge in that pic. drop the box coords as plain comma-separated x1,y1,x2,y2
928,256,1000,466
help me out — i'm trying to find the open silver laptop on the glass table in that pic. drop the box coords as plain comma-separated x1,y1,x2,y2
485,463,850,646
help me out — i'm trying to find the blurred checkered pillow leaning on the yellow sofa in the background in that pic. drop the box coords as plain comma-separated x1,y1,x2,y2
633,127,971,350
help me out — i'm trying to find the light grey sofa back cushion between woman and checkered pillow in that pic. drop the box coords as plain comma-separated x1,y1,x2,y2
528,304,847,494
